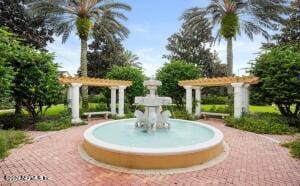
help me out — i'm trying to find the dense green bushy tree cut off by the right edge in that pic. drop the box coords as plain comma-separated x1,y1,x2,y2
251,47,300,125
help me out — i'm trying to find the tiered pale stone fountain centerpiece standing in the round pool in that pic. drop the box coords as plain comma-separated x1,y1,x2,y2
134,80,172,132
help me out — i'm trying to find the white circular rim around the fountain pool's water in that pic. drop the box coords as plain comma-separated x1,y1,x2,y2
84,118,224,156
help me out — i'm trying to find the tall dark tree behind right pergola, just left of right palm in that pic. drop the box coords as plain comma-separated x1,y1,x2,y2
164,8,213,77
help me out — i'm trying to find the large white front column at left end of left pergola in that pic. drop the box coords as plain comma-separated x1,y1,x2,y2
71,83,82,124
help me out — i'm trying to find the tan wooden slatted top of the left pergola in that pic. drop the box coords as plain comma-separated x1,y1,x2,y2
59,76,132,87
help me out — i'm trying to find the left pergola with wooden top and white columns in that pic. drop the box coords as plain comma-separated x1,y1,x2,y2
59,76,132,124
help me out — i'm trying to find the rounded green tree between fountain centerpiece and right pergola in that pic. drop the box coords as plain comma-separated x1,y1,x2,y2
156,61,200,107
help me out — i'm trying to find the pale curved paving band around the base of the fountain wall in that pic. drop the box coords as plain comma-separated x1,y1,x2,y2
78,141,229,175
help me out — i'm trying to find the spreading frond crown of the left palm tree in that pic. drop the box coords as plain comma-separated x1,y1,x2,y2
28,0,131,43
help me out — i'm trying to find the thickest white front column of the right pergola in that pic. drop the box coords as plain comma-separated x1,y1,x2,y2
231,83,245,118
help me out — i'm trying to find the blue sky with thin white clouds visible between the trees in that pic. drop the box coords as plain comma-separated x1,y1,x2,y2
48,0,264,77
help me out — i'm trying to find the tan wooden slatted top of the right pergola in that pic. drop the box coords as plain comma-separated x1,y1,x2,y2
179,76,259,87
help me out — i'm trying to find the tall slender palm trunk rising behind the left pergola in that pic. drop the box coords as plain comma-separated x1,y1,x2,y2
80,39,89,109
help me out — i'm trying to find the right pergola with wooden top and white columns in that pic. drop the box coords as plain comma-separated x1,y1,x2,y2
179,76,259,118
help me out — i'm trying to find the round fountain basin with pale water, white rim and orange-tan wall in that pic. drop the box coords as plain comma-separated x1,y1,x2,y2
83,119,223,169
